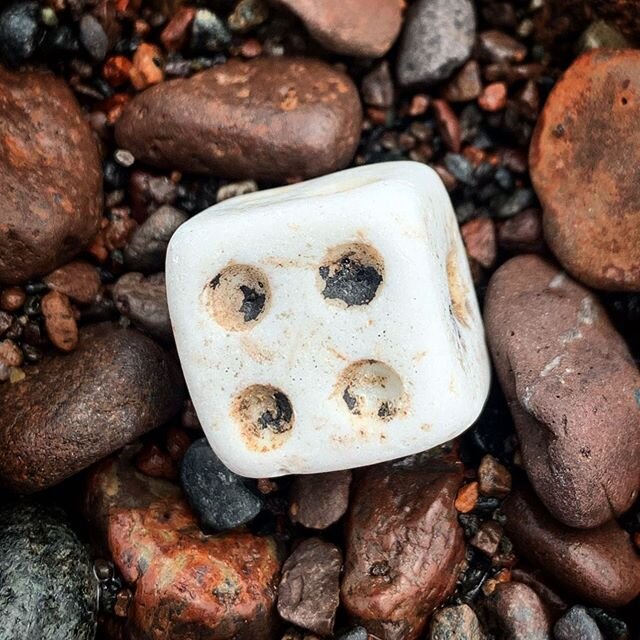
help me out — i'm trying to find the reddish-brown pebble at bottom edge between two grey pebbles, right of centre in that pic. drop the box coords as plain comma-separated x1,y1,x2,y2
486,582,552,640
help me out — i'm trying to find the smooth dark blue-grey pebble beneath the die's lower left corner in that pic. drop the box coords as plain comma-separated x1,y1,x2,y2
180,438,263,531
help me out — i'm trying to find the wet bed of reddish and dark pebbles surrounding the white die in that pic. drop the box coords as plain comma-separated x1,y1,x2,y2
0,0,640,640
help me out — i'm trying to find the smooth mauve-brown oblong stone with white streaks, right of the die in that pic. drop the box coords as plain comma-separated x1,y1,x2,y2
485,256,640,527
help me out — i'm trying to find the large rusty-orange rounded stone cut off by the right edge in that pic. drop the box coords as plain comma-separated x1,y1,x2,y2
530,49,640,291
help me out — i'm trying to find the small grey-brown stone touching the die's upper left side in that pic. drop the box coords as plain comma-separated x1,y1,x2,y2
124,205,188,273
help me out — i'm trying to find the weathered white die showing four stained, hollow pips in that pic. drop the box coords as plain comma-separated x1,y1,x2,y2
167,162,490,477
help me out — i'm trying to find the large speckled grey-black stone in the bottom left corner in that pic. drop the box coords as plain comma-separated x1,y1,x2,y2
0,503,97,640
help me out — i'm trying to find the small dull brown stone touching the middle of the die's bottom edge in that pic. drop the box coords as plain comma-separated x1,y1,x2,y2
289,469,351,529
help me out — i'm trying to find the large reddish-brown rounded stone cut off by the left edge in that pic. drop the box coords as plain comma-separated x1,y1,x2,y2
0,67,102,283
